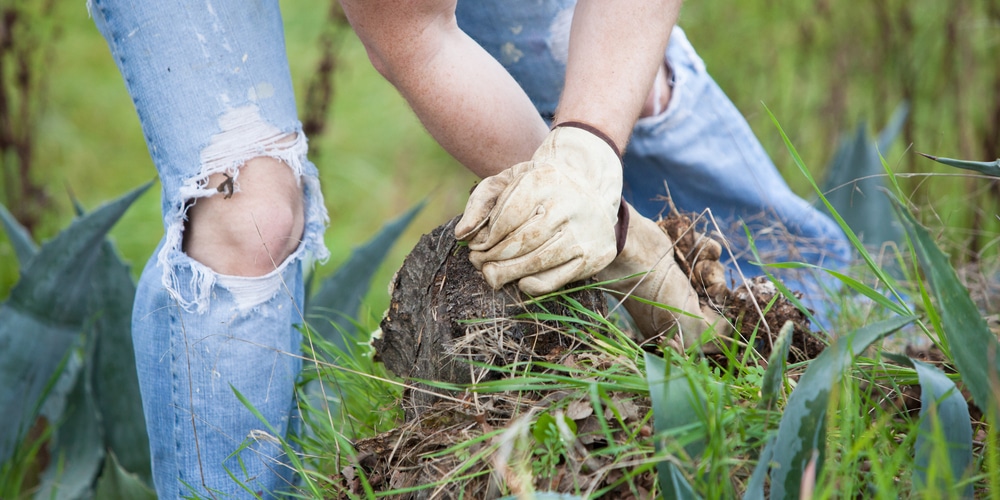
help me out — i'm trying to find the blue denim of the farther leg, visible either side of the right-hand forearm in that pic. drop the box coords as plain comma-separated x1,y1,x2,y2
457,5,850,322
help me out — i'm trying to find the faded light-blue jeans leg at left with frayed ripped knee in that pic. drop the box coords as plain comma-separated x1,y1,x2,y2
88,0,328,498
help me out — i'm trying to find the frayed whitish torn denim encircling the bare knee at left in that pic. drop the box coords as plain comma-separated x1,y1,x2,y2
156,105,330,313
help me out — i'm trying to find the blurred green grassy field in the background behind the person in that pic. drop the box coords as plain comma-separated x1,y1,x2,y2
0,0,1000,324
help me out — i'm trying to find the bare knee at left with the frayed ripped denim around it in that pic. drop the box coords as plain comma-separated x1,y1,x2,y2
156,105,329,312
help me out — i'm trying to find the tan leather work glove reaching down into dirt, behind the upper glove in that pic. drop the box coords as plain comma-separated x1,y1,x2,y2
597,206,731,352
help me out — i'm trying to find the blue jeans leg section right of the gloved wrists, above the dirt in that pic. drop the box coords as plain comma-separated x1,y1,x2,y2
624,28,850,318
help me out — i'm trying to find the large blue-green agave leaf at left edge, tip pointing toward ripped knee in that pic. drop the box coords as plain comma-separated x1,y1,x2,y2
0,184,150,462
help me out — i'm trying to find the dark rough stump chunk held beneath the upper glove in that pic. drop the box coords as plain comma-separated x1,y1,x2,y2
373,217,607,420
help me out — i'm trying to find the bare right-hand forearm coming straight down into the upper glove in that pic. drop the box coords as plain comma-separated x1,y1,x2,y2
555,0,681,150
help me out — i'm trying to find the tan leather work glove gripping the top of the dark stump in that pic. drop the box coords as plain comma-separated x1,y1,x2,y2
455,124,622,295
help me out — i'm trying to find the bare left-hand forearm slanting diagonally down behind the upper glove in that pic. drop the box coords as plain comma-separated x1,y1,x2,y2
342,0,548,177
